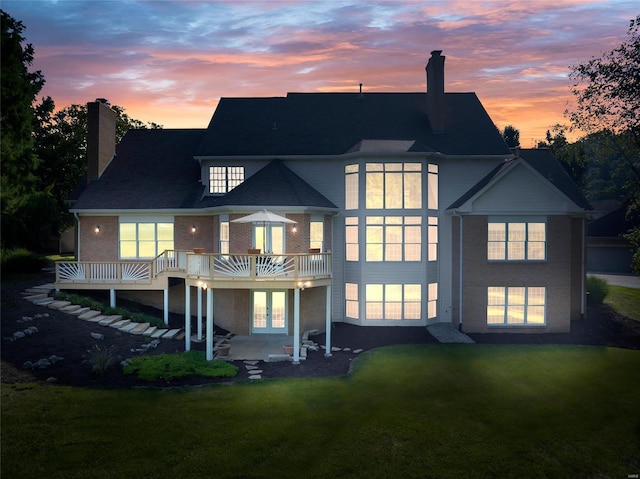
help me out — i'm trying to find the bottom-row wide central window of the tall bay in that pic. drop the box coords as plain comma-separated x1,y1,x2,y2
365,284,422,321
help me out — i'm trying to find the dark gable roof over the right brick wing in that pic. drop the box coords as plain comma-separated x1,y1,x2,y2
447,148,592,210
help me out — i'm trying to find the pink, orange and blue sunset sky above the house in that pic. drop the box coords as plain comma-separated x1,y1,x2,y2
1,0,640,148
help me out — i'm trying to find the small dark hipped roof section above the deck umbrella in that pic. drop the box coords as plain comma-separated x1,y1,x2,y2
196,160,338,209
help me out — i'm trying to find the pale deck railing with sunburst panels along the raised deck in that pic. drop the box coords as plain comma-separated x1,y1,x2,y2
56,250,331,284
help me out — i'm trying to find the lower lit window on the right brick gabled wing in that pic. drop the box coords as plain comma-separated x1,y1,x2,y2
487,286,547,326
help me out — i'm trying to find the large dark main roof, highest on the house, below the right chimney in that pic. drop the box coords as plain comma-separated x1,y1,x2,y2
196,93,510,157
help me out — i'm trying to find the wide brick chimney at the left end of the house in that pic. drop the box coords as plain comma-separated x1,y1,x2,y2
87,98,116,183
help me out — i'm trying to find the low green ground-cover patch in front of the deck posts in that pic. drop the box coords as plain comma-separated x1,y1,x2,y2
123,351,238,381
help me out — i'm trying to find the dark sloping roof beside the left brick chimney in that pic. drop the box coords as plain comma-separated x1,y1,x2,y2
72,129,204,211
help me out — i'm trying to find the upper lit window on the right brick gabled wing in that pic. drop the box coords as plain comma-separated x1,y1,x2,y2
487,220,547,261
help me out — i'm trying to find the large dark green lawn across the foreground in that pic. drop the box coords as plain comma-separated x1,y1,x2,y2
1,345,640,479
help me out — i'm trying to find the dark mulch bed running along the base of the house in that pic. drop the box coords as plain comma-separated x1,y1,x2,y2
0,275,640,388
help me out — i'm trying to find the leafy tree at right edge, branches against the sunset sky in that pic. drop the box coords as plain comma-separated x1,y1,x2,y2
566,15,640,273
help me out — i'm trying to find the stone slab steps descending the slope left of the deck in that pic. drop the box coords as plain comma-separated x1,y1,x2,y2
22,284,184,340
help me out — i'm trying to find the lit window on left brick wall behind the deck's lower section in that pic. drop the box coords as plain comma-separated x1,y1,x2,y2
118,221,173,259
